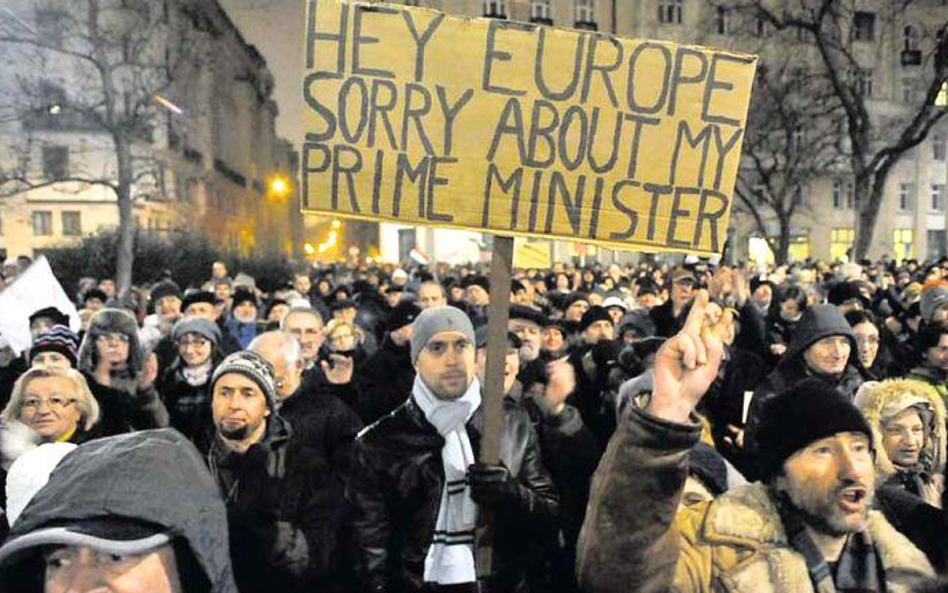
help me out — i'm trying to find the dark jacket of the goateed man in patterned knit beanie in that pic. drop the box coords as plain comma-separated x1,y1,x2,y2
202,403,344,593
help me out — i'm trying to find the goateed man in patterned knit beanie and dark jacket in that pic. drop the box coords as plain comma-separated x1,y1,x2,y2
202,351,344,593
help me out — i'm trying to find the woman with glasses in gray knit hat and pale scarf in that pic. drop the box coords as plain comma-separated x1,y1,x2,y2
157,317,224,440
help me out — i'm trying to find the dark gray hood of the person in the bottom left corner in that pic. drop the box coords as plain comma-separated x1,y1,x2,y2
0,430,237,593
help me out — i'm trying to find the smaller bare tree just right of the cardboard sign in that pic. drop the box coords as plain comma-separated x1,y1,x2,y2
735,59,839,263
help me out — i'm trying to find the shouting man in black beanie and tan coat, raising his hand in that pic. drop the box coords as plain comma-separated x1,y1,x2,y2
578,291,934,593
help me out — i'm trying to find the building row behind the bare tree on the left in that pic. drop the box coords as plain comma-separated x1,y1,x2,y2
0,0,301,256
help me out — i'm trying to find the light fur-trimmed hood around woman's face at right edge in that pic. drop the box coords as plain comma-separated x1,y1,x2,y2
855,379,946,483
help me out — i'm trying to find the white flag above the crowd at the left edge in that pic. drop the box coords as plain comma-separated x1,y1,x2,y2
0,256,80,356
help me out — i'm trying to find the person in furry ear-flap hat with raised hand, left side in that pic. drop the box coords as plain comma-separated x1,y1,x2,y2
79,309,168,436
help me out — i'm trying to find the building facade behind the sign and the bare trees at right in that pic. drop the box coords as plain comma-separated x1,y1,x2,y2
380,0,948,260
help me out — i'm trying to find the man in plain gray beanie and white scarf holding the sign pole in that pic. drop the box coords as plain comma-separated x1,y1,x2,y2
349,306,559,593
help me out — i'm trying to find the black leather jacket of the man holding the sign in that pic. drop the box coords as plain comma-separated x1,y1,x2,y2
348,390,559,593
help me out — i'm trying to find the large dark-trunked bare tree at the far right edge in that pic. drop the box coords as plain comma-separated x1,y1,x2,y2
709,0,948,258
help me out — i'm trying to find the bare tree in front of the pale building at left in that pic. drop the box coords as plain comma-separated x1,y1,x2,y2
0,0,194,292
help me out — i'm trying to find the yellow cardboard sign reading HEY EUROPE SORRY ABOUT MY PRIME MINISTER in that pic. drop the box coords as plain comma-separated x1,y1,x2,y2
301,0,756,254
